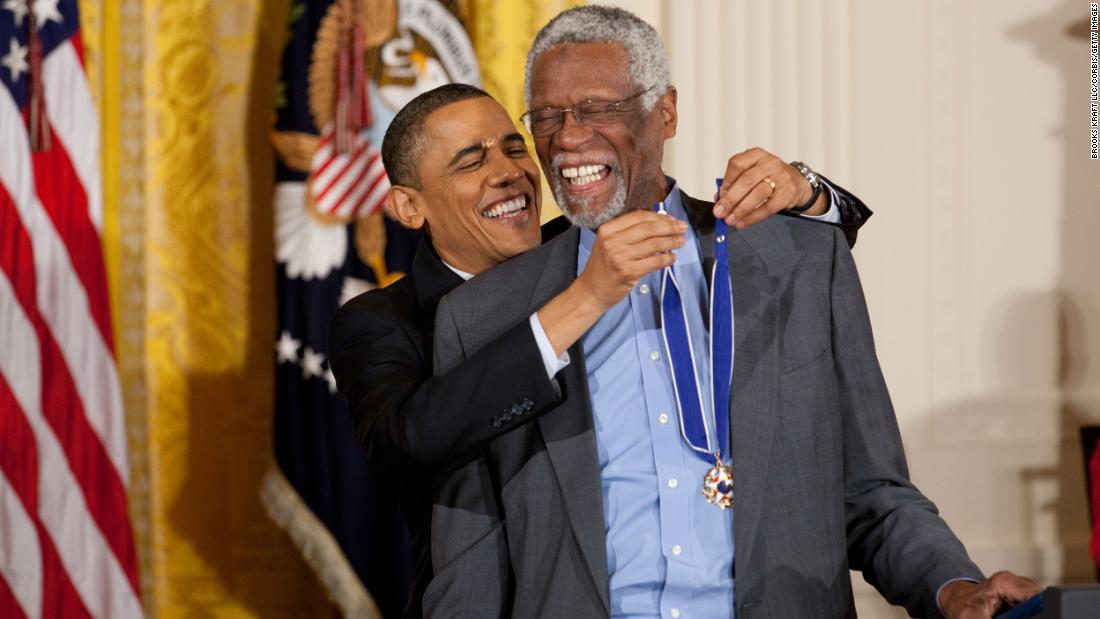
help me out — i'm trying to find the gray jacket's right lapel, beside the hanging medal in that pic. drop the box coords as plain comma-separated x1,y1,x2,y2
681,192,779,565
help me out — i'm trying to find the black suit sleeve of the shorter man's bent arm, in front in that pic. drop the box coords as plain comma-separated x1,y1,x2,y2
329,299,559,467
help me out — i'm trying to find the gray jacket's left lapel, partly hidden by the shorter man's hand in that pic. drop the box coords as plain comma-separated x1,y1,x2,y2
529,228,611,614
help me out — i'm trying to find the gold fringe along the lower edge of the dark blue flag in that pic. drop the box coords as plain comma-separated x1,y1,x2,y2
260,464,383,619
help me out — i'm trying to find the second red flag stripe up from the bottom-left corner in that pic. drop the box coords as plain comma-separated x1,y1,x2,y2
0,373,91,618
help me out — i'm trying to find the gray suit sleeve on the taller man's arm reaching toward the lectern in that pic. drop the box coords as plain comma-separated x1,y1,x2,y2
831,231,982,617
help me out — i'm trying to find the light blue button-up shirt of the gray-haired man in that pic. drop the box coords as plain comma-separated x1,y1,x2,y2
578,179,734,618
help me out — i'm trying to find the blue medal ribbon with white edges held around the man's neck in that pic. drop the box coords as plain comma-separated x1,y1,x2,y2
657,179,734,463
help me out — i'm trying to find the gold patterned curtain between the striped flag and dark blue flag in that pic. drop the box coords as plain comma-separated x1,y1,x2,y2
90,0,333,618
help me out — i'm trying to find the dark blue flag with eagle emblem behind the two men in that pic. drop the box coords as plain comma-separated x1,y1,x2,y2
261,0,481,617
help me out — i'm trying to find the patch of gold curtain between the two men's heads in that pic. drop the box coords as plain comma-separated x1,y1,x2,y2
466,0,584,222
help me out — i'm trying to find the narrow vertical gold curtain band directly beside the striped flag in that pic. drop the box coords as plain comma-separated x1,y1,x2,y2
94,0,155,617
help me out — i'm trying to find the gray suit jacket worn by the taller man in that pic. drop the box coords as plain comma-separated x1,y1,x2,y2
424,191,981,619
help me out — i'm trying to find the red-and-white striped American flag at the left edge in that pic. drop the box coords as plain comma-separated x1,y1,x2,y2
0,0,142,618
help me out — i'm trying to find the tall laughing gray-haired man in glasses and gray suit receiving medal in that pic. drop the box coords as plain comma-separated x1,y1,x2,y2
425,7,1037,619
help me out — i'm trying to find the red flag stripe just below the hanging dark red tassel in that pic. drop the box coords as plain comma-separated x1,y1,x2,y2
33,125,114,355
